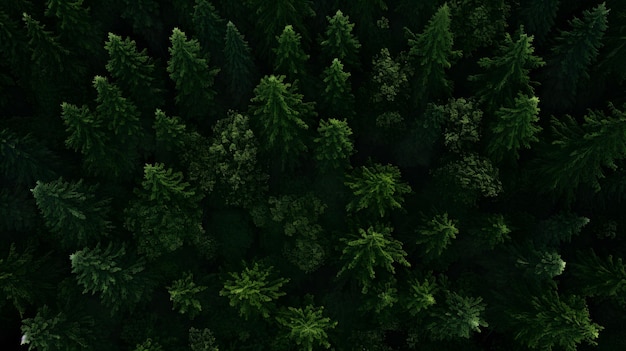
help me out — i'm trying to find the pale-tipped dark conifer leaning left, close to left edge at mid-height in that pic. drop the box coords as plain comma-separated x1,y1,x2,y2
31,178,112,248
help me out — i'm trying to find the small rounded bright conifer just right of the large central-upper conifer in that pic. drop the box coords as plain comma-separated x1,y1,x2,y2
313,118,354,170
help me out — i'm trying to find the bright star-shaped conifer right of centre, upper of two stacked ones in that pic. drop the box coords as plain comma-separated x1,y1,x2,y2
345,164,411,218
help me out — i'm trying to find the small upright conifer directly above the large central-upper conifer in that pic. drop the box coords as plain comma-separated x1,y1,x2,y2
273,25,309,80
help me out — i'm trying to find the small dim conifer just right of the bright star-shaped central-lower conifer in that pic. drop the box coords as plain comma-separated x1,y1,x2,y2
416,213,459,257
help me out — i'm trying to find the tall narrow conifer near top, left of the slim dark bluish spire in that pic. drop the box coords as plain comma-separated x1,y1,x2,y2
167,28,220,120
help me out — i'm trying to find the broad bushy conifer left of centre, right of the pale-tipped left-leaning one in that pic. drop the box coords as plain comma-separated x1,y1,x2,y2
125,163,204,259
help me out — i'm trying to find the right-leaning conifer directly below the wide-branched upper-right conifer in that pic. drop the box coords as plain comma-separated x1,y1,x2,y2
487,94,541,162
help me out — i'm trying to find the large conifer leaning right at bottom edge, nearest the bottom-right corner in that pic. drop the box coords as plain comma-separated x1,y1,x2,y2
512,291,603,351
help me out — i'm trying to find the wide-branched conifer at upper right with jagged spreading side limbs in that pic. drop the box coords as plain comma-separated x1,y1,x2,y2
469,28,545,112
